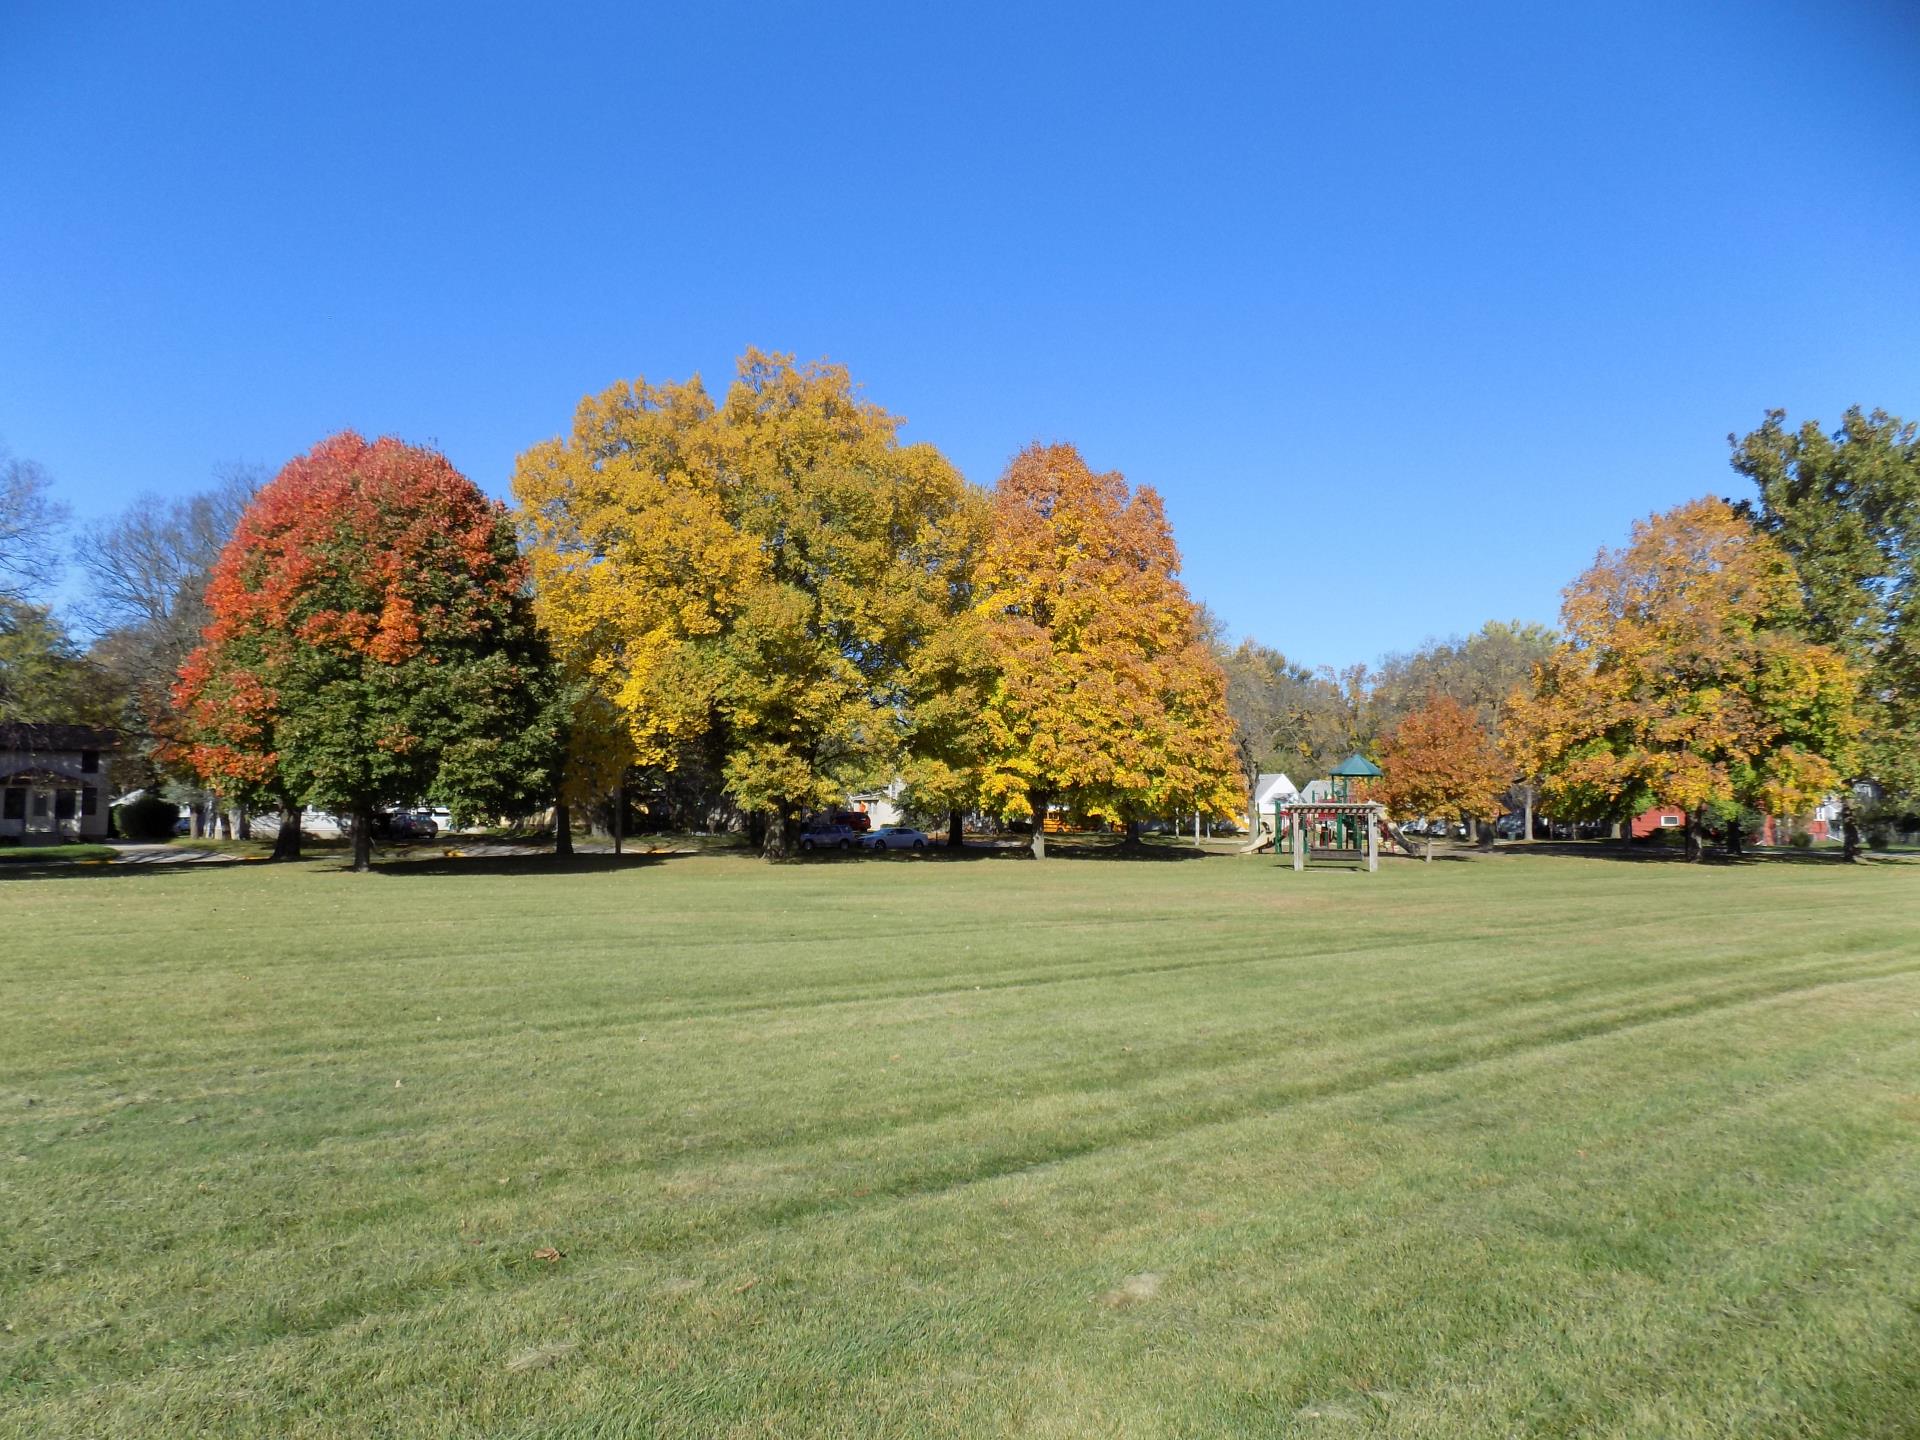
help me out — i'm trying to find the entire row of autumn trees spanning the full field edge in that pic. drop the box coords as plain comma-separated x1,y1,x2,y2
0,372,1920,864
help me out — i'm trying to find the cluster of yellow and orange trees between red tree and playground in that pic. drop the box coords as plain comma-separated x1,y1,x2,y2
513,351,1233,854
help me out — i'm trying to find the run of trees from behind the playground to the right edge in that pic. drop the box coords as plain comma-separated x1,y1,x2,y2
1223,409,1920,858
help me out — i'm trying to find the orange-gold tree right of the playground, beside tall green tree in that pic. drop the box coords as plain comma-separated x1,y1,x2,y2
1507,499,1860,860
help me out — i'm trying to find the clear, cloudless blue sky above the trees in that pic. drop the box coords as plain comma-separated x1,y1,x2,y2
0,0,1920,662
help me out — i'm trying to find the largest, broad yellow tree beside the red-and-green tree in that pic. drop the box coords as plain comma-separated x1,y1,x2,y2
515,351,977,854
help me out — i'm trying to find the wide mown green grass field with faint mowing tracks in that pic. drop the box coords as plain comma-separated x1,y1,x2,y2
0,854,1920,1440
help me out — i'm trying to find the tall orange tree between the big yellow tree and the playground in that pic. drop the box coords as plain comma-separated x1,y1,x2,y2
979,445,1236,858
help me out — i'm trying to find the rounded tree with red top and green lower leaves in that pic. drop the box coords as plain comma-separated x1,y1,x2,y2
173,432,563,870
